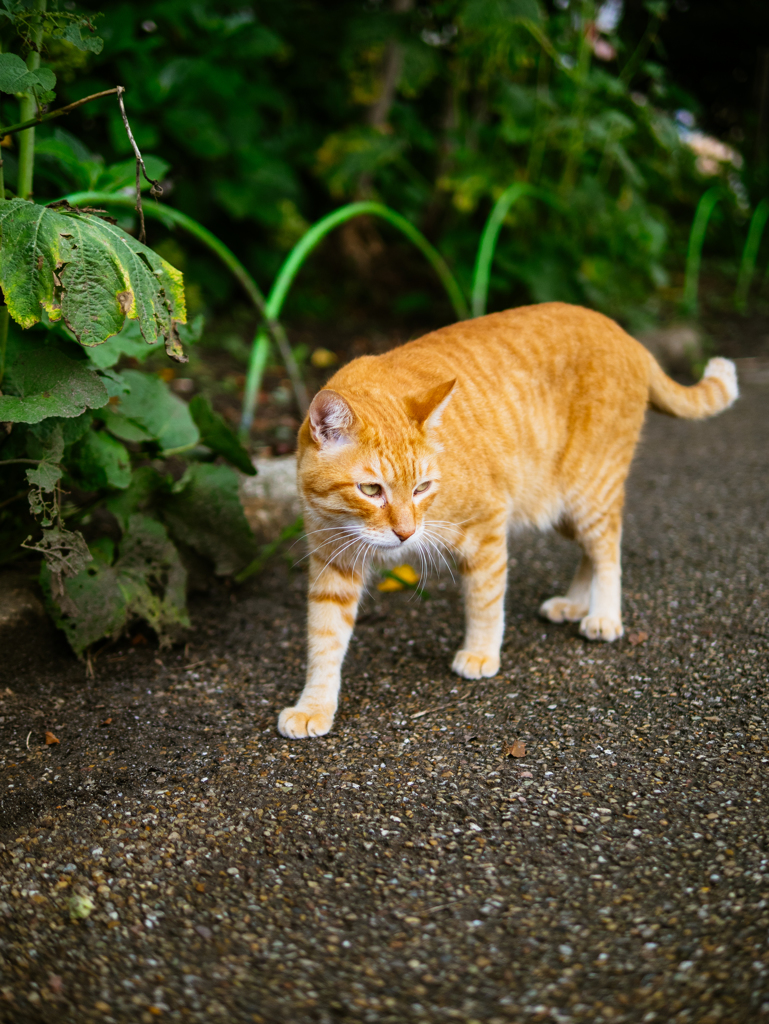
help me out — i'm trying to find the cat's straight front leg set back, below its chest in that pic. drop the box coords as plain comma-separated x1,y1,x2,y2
452,520,507,679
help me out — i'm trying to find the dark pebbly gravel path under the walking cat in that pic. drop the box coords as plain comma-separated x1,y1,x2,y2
0,364,769,1024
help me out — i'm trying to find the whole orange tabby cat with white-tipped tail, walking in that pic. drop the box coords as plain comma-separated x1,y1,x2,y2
277,302,737,738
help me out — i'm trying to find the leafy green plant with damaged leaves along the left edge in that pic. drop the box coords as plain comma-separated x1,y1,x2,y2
0,0,255,655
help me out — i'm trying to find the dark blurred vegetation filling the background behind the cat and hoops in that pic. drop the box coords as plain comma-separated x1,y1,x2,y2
1,0,769,360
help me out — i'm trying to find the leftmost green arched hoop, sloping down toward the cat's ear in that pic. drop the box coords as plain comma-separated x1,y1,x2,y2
65,191,309,415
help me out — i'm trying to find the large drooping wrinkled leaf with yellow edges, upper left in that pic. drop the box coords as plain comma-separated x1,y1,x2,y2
0,199,186,361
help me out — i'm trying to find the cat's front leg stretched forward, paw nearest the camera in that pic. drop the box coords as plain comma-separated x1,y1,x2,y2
277,555,364,739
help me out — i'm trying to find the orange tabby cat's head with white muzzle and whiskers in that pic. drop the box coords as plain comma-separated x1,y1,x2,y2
299,380,456,554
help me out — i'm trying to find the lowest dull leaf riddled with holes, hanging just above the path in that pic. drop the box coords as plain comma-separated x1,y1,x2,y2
41,515,189,655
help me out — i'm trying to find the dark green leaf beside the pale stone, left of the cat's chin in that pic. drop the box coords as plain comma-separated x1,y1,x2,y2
161,463,256,575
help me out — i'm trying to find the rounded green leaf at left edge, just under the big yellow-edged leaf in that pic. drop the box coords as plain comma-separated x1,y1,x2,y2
0,342,109,423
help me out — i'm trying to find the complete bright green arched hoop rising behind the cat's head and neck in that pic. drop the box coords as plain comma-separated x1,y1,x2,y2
241,203,470,434
